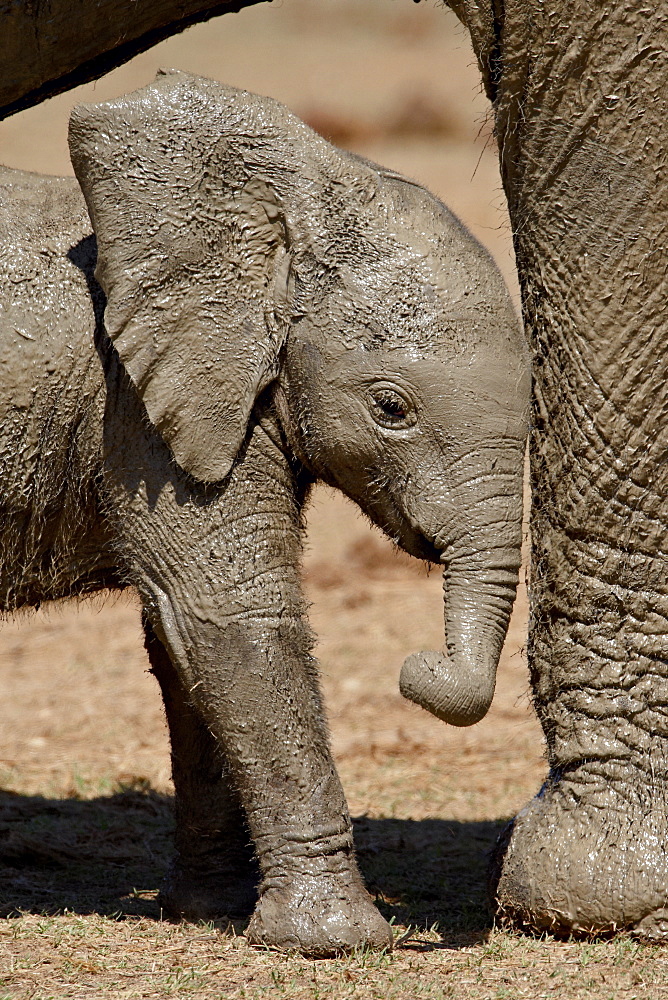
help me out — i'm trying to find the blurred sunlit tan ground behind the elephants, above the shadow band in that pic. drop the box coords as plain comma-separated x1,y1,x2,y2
0,0,543,821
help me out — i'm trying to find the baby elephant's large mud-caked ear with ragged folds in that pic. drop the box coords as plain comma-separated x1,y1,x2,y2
70,74,289,481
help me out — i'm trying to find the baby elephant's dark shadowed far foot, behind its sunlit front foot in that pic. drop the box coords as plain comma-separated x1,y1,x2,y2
158,858,259,923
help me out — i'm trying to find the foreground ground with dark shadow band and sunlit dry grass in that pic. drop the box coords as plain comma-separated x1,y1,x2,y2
0,789,668,1000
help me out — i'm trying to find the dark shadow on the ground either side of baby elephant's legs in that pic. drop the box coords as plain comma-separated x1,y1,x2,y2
0,786,504,948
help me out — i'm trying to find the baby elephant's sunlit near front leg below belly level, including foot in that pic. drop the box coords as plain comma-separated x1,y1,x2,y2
183,619,392,955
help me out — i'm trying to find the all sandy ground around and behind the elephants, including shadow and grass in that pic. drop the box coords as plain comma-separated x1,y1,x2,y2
0,0,668,1000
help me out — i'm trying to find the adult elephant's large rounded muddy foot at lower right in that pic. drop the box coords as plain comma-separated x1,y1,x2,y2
492,760,668,941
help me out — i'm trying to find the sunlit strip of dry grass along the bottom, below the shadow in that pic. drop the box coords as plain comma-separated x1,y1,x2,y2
0,884,668,1000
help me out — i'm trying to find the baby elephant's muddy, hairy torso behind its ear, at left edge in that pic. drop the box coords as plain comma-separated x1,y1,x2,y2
0,168,115,611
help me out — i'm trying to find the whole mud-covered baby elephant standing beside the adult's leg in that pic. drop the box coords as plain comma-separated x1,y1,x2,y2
0,73,528,955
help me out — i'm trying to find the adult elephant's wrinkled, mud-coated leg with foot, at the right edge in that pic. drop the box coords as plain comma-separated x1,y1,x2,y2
448,0,668,939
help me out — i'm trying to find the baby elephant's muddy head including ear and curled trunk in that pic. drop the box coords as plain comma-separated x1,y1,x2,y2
70,73,528,725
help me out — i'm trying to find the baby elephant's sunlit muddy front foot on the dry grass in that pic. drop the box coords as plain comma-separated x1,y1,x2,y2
246,871,392,958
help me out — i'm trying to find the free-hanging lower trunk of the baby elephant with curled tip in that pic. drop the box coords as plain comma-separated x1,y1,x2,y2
399,545,519,726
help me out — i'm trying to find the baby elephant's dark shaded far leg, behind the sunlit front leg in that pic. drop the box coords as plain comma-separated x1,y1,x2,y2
144,620,259,920
